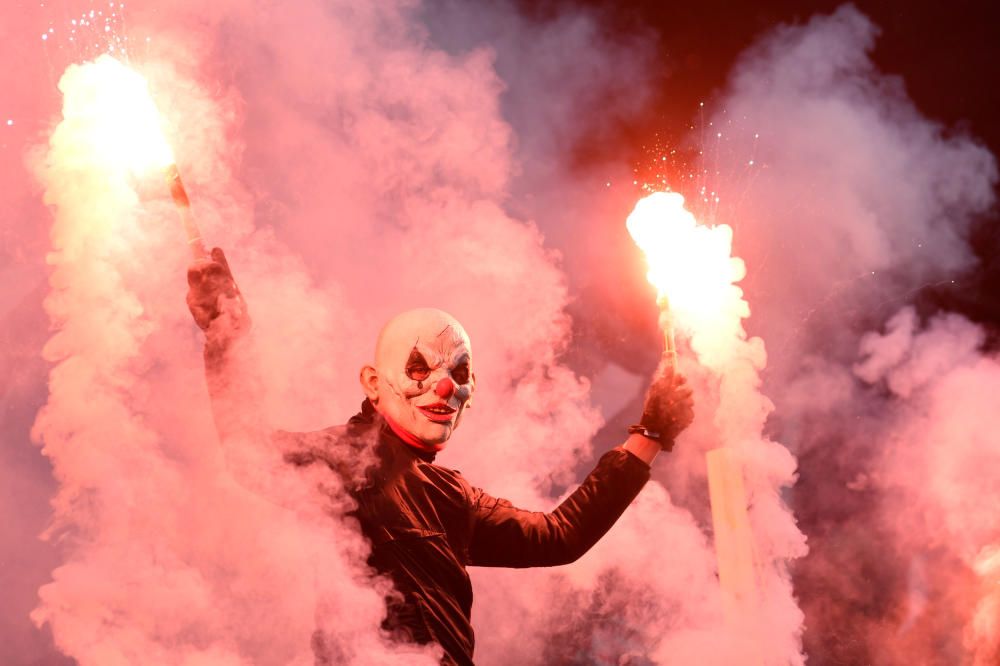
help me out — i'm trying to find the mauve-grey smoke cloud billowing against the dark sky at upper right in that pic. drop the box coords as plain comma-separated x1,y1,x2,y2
707,6,996,363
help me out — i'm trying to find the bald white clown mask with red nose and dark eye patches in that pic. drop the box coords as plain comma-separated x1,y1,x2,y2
361,308,476,451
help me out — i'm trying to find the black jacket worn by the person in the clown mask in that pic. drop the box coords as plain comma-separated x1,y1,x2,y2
282,401,649,664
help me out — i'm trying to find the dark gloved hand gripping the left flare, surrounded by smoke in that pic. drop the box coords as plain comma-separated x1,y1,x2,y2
187,247,250,344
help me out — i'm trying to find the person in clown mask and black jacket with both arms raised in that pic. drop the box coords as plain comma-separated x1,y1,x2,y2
187,248,693,664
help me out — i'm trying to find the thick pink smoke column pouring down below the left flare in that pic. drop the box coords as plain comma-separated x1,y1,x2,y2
33,53,442,664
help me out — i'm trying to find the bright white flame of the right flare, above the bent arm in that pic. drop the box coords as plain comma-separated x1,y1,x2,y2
625,192,750,360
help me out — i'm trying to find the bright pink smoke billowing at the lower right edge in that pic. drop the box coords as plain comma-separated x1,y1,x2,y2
855,308,1000,665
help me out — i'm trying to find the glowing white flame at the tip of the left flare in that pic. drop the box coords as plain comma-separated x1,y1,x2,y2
59,55,174,174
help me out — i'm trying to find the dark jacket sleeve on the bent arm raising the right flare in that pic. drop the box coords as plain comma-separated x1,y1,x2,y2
469,448,649,567
